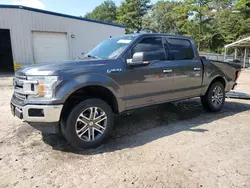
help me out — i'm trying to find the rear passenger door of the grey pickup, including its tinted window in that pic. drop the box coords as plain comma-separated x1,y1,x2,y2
166,37,203,99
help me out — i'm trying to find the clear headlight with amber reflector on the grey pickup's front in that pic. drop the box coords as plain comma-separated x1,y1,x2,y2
27,76,59,99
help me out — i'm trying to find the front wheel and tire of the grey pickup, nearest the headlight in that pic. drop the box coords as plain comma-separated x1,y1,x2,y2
63,99,114,149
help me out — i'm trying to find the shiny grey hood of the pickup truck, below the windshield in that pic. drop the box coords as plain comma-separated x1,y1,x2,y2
17,59,106,76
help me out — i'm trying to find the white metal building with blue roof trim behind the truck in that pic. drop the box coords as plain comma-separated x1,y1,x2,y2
0,5,125,72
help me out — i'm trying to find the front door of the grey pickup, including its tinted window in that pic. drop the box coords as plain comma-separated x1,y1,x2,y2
122,37,173,109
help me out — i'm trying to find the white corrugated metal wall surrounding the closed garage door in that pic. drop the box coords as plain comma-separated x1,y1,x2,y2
0,8,125,64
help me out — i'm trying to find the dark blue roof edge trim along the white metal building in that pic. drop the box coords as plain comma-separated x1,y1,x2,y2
0,4,126,28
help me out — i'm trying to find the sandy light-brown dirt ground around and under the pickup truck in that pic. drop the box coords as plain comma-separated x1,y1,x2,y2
0,70,250,188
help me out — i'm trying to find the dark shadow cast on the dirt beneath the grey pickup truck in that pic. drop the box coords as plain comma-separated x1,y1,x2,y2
43,99,250,155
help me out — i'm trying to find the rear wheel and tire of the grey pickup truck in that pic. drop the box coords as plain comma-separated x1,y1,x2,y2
201,82,225,112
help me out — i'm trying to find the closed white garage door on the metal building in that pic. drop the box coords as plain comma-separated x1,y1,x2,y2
32,32,69,63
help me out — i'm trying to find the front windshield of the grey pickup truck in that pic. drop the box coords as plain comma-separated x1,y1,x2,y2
85,36,135,59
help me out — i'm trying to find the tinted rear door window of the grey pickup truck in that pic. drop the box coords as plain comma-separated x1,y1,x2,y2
167,39,194,60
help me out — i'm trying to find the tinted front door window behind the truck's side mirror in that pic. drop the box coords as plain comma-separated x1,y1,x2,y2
132,37,166,61
